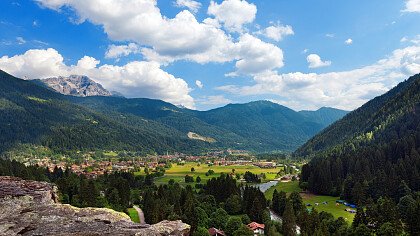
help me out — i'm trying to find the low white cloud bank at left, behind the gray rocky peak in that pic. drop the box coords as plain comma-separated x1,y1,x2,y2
0,48,194,108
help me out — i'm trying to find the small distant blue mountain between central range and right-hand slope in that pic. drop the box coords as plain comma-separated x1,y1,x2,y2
299,107,349,126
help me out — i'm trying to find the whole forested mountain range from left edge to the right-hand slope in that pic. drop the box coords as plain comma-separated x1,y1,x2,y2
0,69,344,153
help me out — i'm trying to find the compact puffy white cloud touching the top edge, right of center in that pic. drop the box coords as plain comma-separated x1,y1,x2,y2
207,0,257,32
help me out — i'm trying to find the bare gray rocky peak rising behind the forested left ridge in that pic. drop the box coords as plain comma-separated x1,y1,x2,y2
41,75,112,97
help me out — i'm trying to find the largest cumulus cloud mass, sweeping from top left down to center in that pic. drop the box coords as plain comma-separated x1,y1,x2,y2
36,0,283,73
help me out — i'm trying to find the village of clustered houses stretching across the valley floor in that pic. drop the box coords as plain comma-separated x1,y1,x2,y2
13,149,299,181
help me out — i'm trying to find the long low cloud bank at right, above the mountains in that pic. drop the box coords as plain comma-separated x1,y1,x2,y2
218,44,420,110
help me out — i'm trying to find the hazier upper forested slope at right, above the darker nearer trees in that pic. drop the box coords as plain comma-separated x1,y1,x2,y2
295,75,419,156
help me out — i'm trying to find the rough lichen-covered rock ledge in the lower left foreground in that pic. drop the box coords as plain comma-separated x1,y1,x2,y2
0,176,190,236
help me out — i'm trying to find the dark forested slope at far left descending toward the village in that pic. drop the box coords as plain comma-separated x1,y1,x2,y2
0,71,206,153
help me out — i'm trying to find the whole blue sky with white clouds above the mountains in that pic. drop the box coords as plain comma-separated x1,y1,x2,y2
0,0,420,110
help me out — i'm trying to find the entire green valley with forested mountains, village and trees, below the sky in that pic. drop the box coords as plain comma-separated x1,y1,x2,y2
0,67,420,235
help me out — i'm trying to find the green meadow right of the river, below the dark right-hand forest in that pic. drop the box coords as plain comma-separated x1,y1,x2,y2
265,181,355,224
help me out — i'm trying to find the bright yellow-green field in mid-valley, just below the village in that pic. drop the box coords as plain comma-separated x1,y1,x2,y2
136,162,280,184
